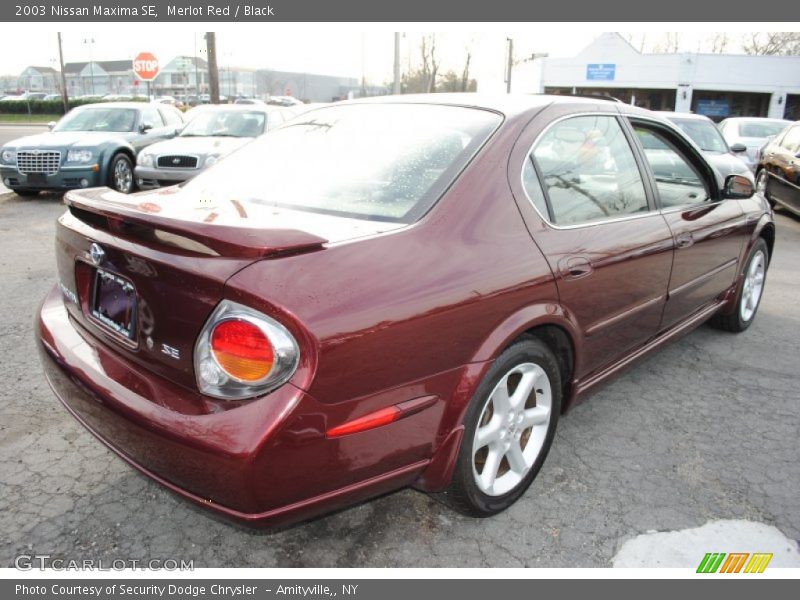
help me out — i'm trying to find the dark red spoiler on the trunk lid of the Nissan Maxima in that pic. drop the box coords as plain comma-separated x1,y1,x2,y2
64,188,328,258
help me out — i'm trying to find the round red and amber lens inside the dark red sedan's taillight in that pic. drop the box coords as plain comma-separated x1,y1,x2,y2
211,319,275,383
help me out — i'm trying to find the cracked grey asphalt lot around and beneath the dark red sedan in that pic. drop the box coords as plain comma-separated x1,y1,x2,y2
0,152,800,567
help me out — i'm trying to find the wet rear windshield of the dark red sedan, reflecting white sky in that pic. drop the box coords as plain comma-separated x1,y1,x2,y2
185,104,501,223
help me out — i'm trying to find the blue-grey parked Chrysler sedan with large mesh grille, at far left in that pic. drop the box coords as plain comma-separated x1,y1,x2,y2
0,102,183,196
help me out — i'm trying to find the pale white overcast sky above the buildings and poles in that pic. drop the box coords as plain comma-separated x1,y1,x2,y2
0,23,780,84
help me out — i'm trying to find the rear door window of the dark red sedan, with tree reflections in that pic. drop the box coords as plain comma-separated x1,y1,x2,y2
523,115,649,225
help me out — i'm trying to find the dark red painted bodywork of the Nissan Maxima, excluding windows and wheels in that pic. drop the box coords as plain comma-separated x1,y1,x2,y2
37,96,774,525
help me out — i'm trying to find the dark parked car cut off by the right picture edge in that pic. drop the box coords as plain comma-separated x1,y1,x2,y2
756,121,800,215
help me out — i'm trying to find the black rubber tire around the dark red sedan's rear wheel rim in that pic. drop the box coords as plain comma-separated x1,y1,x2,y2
438,336,562,517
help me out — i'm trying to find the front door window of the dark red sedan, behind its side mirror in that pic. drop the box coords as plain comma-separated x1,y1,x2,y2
634,125,709,208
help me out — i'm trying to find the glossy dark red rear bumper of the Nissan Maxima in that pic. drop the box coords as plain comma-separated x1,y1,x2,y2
37,287,440,527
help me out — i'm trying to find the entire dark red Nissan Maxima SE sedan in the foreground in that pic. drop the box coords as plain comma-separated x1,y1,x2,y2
37,95,775,525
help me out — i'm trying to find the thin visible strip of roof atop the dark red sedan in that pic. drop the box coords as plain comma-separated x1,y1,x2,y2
344,93,624,116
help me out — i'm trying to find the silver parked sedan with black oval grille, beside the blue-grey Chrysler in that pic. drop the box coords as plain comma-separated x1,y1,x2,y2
135,104,288,190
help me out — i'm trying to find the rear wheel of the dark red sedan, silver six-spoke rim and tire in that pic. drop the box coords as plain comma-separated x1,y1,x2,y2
442,337,561,517
